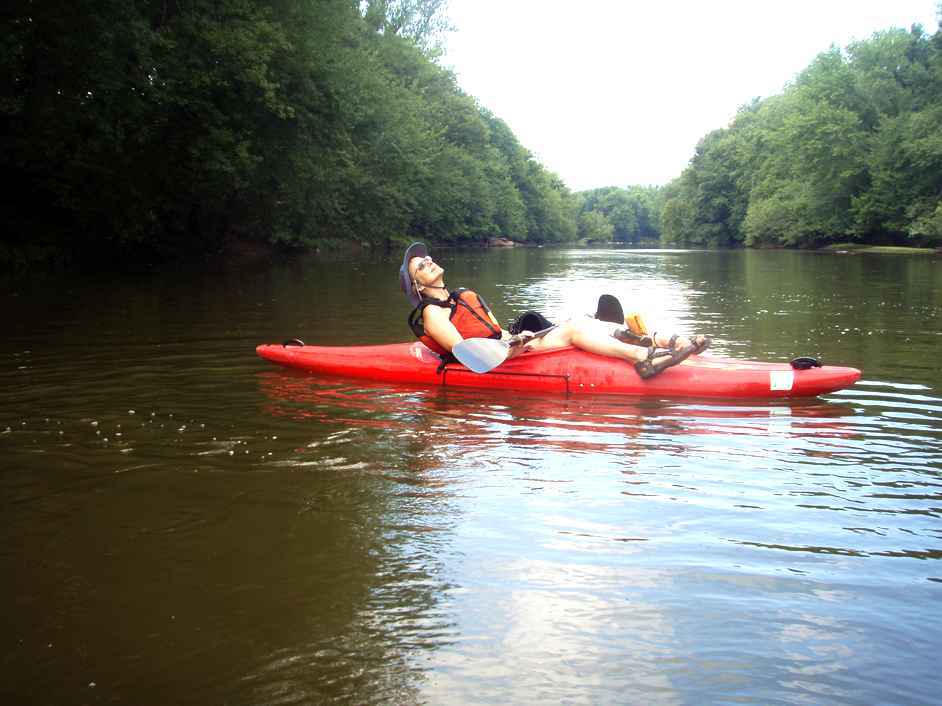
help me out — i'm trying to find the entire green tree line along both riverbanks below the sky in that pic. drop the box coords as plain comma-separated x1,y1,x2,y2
0,0,942,267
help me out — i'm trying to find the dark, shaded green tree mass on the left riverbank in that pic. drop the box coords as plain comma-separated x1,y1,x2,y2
0,0,576,266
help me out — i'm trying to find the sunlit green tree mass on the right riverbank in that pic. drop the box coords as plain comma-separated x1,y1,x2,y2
661,17,942,247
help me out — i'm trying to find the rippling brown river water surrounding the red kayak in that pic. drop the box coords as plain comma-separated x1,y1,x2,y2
0,249,942,705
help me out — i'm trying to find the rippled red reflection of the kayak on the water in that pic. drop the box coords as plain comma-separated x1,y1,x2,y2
257,370,854,452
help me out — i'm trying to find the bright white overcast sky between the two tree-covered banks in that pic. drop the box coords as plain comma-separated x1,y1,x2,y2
441,0,939,191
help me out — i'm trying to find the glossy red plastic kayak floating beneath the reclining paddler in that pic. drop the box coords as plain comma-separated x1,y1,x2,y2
255,341,860,399
